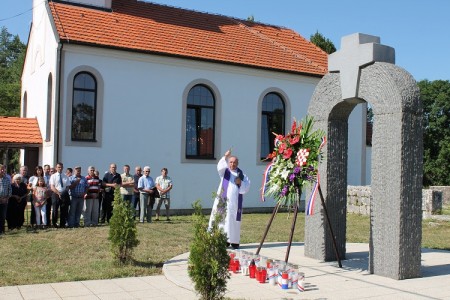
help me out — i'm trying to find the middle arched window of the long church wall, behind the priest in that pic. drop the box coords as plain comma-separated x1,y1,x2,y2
186,85,215,159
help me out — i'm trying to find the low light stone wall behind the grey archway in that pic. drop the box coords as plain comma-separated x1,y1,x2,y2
347,185,444,218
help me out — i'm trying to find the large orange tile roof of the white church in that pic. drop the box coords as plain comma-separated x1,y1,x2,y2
49,0,328,76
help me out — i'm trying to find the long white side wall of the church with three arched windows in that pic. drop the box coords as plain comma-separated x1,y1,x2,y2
51,45,348,209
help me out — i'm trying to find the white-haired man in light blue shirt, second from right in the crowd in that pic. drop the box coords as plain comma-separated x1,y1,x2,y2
138,166,155,223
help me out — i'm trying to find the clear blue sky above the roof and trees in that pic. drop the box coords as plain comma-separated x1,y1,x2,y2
0,0,450,81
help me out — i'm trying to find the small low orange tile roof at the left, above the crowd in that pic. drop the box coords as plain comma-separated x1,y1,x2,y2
0,116,42,146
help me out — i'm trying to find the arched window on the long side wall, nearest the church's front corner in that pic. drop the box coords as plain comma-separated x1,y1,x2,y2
72,72,97,142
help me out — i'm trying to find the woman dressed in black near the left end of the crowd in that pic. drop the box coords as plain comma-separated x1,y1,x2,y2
6,174,28,230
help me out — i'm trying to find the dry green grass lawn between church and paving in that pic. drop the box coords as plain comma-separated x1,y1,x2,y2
0,212,450,286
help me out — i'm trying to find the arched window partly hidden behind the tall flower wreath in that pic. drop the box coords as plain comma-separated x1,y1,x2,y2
261,93,285,159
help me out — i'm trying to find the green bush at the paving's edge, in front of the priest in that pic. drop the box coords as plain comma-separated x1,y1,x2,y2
188,200,230,300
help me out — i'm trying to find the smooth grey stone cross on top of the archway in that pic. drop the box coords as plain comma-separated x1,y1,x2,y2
328,33,395,99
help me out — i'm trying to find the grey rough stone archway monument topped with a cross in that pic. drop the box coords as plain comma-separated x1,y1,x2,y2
305,33,423,279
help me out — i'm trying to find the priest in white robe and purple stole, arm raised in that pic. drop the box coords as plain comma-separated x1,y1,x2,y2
209,150,250,249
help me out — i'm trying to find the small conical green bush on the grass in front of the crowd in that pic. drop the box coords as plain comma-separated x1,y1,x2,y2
108,188,139,265
